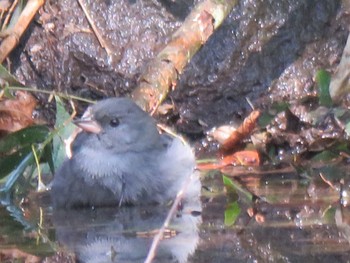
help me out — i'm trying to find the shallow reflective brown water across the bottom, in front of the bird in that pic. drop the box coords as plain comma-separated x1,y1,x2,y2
0,166,350,262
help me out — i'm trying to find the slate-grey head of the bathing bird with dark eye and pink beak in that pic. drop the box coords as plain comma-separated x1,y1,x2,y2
74,98,159,152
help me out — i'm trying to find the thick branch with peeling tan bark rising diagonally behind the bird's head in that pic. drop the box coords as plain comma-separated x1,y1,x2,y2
132,0,237,113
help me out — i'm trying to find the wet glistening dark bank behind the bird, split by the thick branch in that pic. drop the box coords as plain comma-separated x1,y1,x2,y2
6,0,350,138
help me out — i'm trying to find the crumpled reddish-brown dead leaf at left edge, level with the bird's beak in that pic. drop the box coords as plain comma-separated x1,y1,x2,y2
0,91,37,132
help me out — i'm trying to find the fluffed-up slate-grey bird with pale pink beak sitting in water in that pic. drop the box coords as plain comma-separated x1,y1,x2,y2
51,98,200,208
